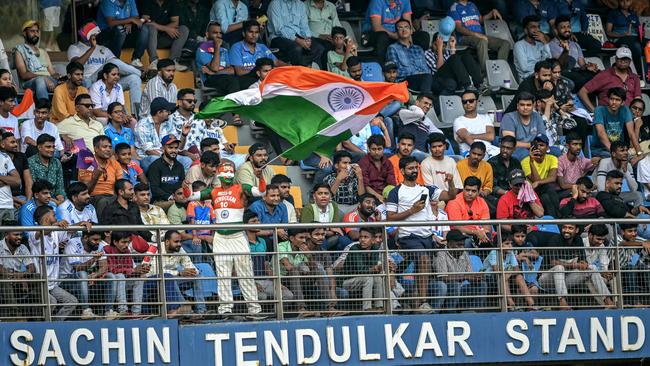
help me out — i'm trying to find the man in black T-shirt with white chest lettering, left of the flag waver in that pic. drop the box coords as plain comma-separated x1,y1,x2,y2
147,134,185,210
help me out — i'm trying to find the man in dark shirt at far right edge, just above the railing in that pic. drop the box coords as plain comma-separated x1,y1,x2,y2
596,169,650,218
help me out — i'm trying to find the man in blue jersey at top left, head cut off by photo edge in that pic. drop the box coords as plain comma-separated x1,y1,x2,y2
97,0,149,61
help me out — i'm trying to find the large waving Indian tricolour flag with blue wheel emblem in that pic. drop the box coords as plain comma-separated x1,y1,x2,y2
196,66,408,160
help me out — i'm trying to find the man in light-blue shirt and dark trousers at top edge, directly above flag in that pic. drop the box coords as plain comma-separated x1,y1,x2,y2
267,0,325,70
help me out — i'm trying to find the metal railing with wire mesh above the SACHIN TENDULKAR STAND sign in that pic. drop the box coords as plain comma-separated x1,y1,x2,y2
0,219,650,321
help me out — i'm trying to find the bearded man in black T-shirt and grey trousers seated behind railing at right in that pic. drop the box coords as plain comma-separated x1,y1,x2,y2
526,224,614,310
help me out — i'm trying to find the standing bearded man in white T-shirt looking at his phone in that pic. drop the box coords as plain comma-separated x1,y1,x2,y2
386,156,454,313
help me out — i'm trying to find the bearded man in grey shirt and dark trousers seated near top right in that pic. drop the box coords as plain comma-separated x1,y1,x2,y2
548,15,598,90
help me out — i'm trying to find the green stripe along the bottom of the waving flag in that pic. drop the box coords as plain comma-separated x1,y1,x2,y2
196,95,352,160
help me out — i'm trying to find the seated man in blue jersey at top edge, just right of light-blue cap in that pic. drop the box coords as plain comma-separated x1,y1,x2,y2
449,0,508,73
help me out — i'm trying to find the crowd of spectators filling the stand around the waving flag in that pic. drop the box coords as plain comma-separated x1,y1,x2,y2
0,0,650,320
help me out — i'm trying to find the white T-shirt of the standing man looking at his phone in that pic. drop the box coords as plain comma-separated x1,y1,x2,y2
386,184,442,238
